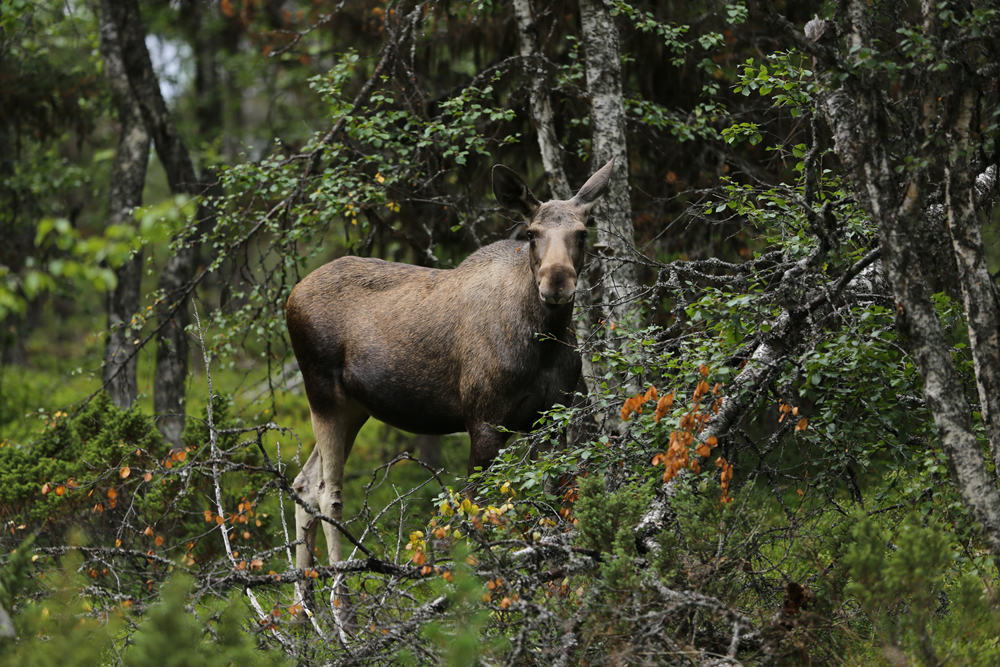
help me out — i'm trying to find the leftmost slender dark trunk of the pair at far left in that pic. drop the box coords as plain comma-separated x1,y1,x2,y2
100,1,149,409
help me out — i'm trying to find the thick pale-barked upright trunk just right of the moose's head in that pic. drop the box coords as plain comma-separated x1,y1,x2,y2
580,0,636,320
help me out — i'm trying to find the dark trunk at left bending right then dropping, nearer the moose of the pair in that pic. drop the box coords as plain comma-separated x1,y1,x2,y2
101,0,212,447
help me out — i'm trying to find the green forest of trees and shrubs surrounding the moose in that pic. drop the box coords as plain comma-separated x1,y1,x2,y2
0,0,1000,666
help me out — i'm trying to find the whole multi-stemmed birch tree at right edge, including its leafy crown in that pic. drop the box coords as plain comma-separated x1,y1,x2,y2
761,1,1000,554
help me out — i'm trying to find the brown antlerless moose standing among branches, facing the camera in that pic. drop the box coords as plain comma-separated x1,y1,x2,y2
285,158,614,612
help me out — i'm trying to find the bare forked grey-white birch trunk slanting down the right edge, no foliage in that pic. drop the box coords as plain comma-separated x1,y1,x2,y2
808,0,1000,554
